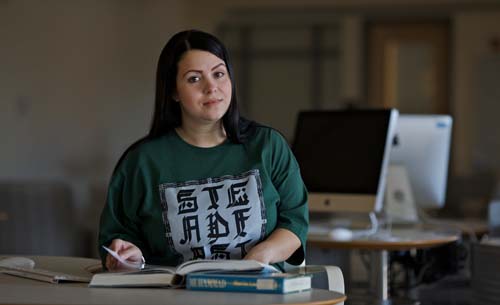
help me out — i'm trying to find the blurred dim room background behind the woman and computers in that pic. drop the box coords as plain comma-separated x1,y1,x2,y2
0,0,500,256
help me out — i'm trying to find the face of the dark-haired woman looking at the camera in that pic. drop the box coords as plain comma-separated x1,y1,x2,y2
174,50,232,124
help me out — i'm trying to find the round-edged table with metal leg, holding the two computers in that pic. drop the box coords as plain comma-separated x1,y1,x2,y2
307,229,459,305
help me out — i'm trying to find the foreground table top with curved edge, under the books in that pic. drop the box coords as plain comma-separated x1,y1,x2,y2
0,256,346,305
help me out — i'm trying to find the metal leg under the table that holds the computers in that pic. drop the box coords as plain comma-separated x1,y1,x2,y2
370,250,391,305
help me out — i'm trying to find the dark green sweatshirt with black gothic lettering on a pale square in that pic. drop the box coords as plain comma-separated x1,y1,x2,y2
99,126,308,265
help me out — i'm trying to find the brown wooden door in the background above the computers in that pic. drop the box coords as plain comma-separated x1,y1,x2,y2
367,21,450,113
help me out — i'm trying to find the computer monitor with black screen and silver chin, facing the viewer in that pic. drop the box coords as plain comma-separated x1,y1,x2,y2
292,109,398,213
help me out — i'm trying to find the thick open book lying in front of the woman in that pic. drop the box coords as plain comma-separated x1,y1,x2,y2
89,260,280,287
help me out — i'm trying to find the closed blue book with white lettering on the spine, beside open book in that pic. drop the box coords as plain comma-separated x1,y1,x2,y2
186,272,311,294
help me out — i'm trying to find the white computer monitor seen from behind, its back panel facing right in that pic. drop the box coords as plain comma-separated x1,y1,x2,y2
387,114,453,210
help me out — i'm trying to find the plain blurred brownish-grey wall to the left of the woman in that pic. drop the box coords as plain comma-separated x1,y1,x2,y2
0,0,186,179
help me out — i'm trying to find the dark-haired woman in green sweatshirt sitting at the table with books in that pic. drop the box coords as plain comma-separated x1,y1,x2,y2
99,30,308,270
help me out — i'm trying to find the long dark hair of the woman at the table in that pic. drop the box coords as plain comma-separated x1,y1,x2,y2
114,30,256,171
